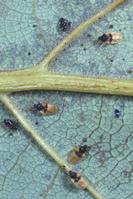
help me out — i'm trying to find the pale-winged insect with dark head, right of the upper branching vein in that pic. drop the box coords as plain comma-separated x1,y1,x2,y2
97,32,122,45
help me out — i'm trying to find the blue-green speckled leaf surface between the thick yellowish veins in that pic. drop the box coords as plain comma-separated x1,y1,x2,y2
0,0,133,199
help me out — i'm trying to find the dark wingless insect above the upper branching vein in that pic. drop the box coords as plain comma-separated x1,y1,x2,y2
57,17,72,32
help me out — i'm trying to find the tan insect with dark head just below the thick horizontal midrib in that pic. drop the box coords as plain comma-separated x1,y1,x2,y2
33,101,59,115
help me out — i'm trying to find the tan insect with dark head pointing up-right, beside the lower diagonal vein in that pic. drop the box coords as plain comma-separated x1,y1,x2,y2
68,145,89,164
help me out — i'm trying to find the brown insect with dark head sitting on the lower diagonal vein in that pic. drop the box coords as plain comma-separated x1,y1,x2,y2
68,171,88,189
